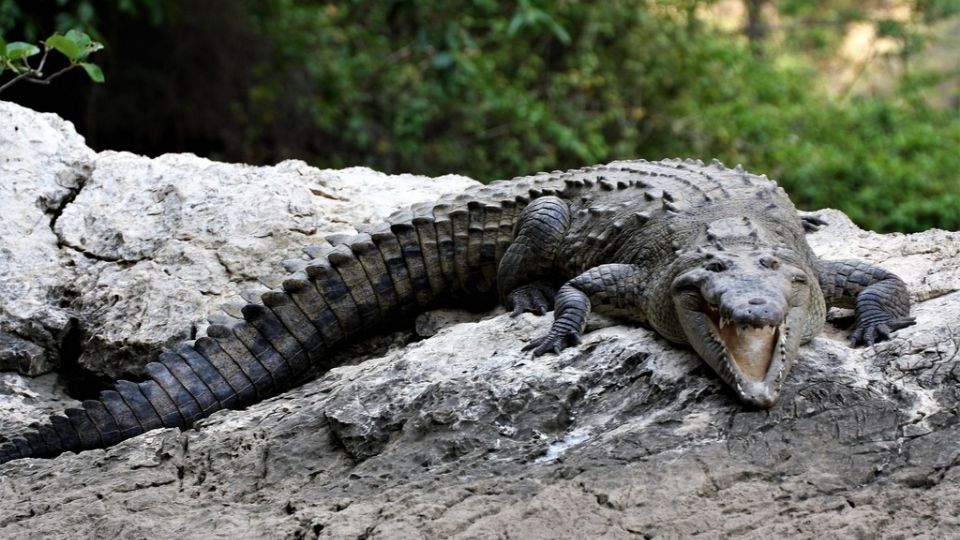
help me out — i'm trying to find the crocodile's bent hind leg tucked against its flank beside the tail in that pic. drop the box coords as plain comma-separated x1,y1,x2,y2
497,196,570,316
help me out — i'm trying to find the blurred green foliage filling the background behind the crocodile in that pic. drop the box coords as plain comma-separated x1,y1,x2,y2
238,0,960,231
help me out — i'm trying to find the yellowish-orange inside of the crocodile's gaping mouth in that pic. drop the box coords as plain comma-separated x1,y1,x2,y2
703,305,784,381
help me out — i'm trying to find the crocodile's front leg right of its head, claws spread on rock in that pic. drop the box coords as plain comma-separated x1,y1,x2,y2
817,260,915,345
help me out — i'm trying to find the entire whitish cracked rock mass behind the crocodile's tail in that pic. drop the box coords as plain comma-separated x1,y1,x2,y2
0,101,476,378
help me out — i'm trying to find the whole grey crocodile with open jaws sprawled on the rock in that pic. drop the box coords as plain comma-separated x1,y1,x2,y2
0,159,913,463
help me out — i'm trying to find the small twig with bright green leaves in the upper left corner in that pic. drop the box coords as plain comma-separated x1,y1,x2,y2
0,30,104,92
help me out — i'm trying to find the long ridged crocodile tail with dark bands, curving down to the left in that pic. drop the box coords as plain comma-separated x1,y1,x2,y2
0,195,526,463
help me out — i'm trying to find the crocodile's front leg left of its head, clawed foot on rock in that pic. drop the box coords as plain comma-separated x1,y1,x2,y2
523,264,644,356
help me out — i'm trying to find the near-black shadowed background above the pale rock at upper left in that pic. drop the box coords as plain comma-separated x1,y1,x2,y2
3,0,262,161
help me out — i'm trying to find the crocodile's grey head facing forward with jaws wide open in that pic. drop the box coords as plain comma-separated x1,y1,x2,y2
671,218,817,408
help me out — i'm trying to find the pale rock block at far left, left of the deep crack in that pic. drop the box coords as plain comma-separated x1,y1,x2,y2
0,101,94,375
